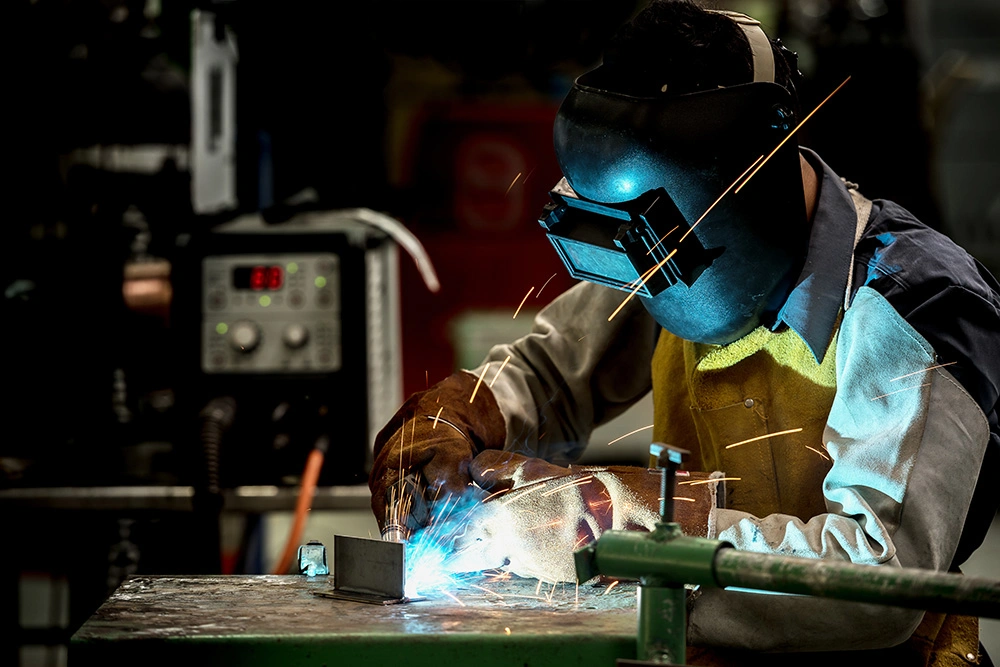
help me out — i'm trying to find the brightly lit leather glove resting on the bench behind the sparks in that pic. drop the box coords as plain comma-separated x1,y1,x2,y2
449,451,722,583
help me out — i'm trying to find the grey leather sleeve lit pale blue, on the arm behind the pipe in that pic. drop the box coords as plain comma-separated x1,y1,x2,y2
689,287,990,651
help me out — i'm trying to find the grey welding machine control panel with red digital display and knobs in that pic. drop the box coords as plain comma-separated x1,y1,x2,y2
201,253,342,374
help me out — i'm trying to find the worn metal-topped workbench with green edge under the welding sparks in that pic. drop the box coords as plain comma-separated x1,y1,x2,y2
69,574,637,667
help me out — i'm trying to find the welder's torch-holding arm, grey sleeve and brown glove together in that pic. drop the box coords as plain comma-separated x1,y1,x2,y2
368,283,659,528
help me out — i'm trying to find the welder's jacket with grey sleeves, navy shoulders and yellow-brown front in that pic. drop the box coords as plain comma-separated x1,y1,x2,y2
470,149,1000,664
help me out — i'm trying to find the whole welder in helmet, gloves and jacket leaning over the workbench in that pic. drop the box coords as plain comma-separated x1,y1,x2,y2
369,0,1000,665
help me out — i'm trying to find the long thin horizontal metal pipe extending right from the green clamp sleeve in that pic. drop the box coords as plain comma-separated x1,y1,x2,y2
716,548,1000,618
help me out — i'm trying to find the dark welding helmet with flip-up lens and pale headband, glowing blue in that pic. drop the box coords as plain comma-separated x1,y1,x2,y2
539,12,808,344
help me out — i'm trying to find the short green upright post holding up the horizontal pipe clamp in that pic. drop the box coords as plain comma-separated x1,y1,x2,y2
636,586,687,665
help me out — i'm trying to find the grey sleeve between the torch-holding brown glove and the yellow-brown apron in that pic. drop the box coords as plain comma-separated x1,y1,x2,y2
472,282,660,464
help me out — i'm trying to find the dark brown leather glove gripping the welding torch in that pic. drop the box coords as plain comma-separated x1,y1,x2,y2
368,371,507,529
